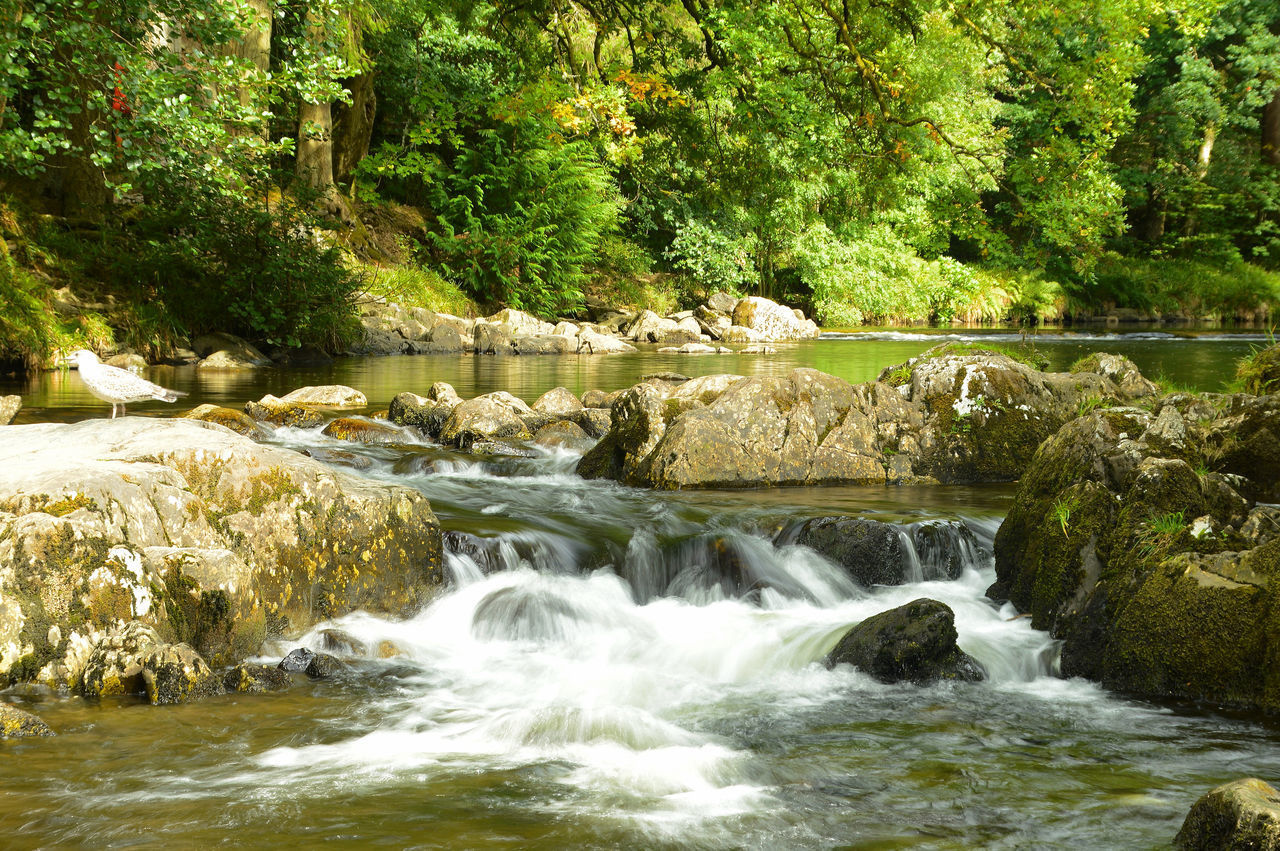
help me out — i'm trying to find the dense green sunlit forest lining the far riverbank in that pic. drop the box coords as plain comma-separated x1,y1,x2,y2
0,0,1280,366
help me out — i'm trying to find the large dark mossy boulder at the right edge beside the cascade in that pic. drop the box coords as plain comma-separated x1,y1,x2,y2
988,395,1280,712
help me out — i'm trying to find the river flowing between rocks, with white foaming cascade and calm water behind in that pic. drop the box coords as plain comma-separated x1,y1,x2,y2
0,333,1280,848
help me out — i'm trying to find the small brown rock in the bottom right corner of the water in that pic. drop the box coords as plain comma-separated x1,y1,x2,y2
1174,777,1280,851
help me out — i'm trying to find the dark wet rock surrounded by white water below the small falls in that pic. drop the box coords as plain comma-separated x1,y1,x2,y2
827,598,987,685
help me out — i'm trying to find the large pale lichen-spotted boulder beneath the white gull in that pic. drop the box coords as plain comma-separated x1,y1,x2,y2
0,417,443,687
